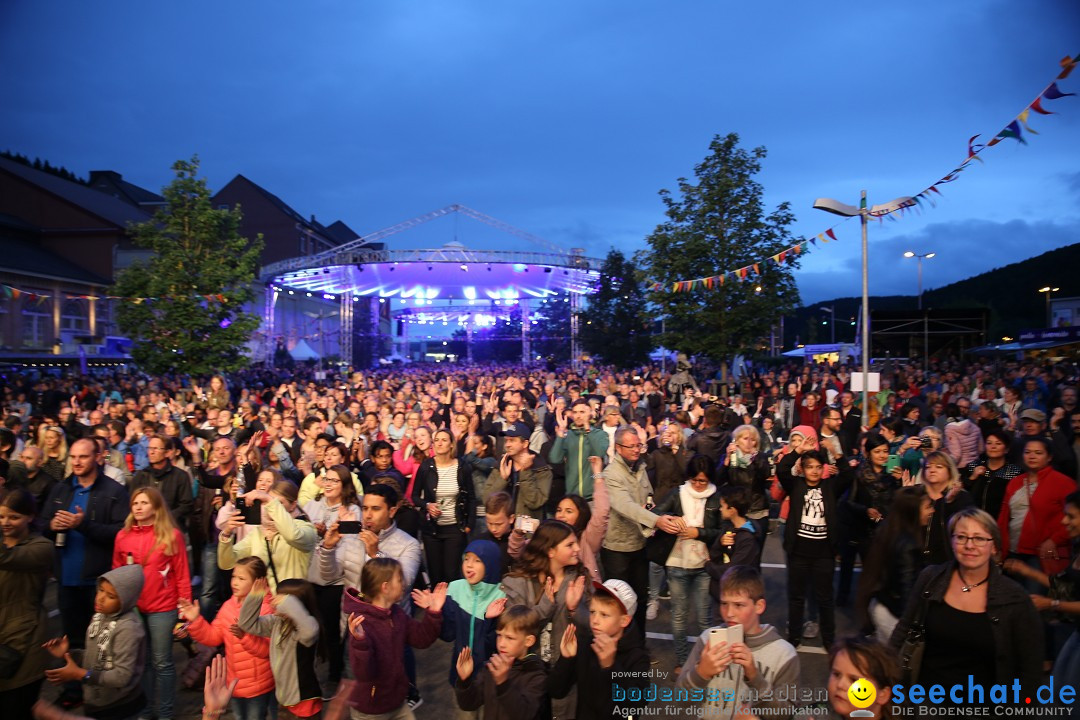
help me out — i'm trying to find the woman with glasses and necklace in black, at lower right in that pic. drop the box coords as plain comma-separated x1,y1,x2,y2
890,507,1042,706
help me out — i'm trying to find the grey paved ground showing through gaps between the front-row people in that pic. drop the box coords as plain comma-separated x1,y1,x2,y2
43,532,854,720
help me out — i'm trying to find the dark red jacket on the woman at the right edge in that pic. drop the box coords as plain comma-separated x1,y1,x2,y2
998,465,1077,572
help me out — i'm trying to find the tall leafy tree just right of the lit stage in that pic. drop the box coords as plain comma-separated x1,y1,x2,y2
637,133,799,359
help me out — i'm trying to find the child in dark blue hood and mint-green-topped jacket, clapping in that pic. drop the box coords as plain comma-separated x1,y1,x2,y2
442,540,507,685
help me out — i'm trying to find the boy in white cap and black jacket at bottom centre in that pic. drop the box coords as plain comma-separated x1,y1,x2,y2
548,580,649,720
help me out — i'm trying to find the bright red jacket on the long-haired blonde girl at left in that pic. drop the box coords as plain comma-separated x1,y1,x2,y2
112,525,191,612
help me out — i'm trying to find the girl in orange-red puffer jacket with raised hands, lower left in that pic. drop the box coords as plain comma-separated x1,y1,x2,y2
180,556,278,720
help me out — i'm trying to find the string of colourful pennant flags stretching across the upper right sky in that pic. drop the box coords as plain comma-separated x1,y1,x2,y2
646,53,1080,293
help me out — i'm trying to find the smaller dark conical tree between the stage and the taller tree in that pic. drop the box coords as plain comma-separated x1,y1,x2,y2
578,249,652,368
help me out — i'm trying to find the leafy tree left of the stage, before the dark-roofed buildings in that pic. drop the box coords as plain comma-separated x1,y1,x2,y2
111,158,262,375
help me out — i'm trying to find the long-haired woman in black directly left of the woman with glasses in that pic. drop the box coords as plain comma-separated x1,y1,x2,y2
856,485,934,642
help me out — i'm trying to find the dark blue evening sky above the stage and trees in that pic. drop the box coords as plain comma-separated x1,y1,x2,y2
0,0,1080,303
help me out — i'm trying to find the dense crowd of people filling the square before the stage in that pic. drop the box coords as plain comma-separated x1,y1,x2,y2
0,362,1080,720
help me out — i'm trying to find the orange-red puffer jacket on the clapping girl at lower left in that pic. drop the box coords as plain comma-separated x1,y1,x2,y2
188,593,274,697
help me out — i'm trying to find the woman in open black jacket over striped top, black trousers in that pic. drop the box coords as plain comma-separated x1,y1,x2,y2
413,430,476,585
